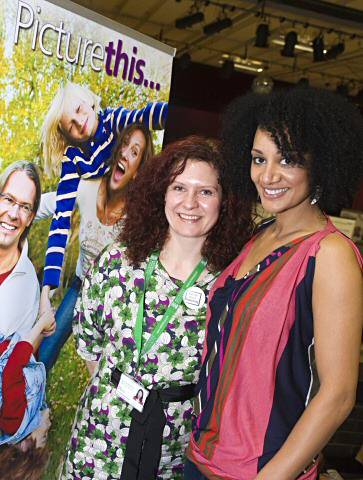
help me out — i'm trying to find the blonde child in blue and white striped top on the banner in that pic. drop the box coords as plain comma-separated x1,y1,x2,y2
40,82,168,312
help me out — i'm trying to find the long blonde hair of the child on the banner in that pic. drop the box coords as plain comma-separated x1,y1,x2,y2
41,82,101,177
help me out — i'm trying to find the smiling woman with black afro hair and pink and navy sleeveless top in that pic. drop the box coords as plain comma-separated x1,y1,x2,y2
188,88,363,480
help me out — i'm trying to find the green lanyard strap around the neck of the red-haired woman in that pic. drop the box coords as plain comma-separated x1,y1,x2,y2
134,252,207,362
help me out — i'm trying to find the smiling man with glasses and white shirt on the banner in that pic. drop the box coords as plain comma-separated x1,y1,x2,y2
0,161,41,337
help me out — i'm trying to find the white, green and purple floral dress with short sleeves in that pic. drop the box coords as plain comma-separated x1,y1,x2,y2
61,244,216,480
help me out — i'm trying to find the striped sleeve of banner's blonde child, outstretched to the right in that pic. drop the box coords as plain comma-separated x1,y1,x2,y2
111,102,168,135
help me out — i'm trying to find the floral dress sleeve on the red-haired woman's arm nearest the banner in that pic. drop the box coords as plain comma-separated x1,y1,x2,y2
73,251,109,361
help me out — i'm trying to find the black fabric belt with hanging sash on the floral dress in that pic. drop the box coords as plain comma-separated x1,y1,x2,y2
111,369,195,480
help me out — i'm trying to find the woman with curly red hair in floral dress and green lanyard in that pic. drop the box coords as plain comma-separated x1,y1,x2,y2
61,137,249,480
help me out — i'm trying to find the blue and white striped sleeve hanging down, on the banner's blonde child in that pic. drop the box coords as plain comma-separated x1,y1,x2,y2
43,148,80,287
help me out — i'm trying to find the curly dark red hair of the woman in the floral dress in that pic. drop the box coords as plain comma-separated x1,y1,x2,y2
119,136,252,272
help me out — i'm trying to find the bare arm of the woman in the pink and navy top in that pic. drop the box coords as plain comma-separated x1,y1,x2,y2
255,234,363,480
